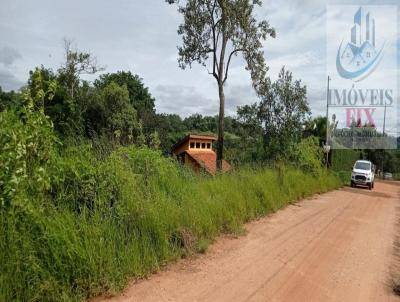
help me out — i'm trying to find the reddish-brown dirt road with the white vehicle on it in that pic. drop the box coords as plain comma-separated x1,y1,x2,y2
99,183,400,302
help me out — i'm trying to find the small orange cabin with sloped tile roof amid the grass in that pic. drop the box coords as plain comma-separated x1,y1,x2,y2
172,134,231,175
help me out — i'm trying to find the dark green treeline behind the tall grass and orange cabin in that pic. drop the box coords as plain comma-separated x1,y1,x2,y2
0,41,325,165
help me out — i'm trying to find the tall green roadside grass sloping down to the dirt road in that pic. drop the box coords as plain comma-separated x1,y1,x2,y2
0,146,341,301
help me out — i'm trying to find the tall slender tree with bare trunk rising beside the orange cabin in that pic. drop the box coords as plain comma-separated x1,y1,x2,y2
166,0,275,169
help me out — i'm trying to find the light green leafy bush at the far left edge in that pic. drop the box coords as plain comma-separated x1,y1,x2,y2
0,110,56,208
